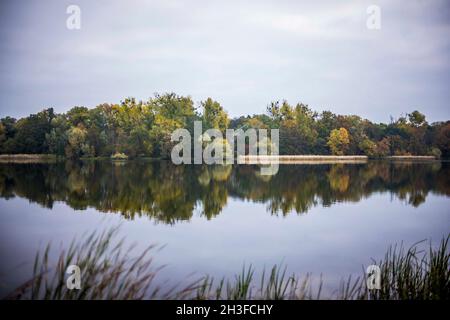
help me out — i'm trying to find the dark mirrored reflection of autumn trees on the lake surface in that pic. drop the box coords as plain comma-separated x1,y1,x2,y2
0,161,450,224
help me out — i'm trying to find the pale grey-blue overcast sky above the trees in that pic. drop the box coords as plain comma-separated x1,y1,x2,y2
0,0,450,122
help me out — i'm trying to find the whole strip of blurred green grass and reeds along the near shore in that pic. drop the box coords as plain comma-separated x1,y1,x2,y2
6,229,450,300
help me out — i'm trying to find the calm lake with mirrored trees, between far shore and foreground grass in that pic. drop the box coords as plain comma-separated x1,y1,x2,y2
0,161,450,296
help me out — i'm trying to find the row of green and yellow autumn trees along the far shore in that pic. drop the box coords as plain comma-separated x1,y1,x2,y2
0,93,450,158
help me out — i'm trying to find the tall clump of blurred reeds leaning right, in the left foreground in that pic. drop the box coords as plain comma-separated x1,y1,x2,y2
7,228,197,300
